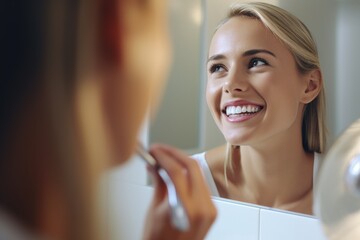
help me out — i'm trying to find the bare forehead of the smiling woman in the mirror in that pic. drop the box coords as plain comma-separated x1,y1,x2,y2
209,16,287,55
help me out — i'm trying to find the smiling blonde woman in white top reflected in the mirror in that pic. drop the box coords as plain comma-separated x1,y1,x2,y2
193,2,325,214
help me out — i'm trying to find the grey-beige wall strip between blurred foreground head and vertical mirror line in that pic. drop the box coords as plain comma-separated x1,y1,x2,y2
150,0,202,152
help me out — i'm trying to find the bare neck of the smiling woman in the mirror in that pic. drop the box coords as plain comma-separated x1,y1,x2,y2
240,140,314,210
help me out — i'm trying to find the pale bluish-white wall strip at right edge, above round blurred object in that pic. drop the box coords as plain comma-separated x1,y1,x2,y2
335,0,360,135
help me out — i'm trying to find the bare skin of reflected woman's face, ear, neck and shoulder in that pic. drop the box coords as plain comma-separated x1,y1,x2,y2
206,17,321,216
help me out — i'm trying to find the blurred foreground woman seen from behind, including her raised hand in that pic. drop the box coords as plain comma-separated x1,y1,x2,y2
0,0,216,239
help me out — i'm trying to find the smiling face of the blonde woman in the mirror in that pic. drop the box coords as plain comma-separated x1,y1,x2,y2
206,16,306,145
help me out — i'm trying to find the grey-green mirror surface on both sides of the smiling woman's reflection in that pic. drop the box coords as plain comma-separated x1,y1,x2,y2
149,0,360,215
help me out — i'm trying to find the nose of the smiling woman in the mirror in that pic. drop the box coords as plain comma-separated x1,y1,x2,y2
223,71,249,93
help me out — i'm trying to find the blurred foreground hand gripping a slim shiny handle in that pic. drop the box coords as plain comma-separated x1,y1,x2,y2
144,145,217,240
